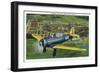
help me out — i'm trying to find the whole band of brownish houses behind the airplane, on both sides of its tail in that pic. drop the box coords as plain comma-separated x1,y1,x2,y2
26,20,88,36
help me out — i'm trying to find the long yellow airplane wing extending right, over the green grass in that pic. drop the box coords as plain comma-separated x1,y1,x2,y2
53,45,86,52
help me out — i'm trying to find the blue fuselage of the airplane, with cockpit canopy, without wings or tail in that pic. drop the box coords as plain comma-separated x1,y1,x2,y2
40,34,70,47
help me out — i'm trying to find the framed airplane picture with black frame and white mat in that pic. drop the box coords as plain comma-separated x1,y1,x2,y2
11,2,97,71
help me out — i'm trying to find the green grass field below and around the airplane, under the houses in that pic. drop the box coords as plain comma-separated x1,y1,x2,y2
26,38,89,59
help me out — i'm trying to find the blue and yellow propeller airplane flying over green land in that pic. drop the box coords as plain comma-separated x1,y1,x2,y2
32,27,86,56
